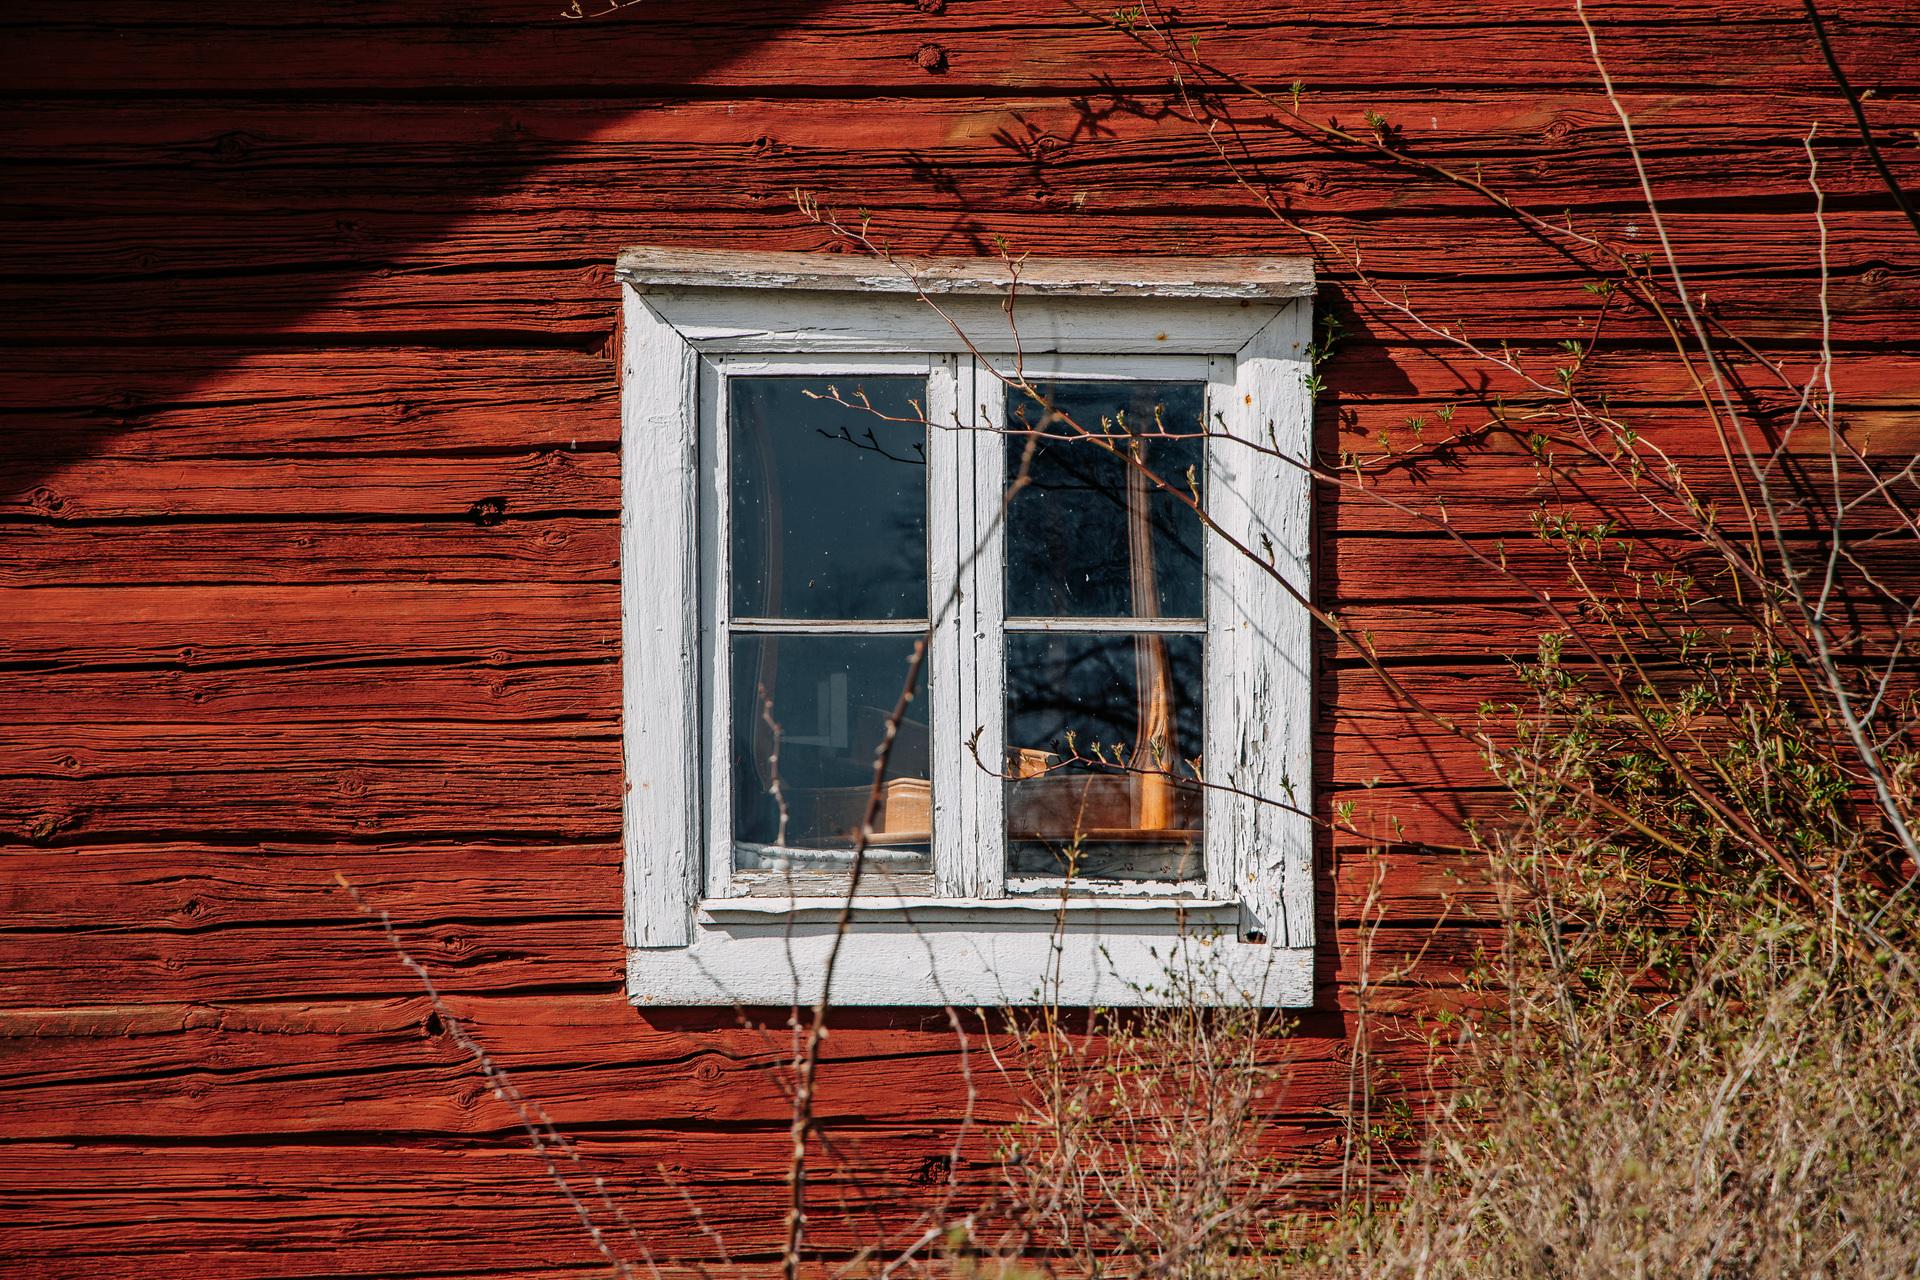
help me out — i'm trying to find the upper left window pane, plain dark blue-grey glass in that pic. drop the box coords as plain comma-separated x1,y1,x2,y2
728,376,927,618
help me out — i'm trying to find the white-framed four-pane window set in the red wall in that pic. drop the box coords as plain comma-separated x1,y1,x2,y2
618,249,1313,1006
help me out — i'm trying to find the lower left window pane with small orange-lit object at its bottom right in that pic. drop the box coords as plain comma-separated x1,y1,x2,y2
732,635,933,871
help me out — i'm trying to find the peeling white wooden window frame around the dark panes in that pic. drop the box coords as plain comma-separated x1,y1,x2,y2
618,249,1313,1007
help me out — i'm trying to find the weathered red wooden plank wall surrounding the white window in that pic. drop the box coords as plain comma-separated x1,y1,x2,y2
0,0,1920,1280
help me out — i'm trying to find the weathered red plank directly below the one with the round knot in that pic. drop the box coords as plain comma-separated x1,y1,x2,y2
0,91,1920,164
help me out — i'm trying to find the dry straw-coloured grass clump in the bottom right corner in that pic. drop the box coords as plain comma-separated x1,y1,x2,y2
1351,921,1920,1280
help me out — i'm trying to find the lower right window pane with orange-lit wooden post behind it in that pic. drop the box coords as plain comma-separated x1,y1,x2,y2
1006,633,1206,881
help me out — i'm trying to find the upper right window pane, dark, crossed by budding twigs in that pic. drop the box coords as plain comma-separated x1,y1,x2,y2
1006,382,1206,618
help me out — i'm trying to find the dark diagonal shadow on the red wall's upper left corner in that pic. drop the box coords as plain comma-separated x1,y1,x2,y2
0,0,833,498
